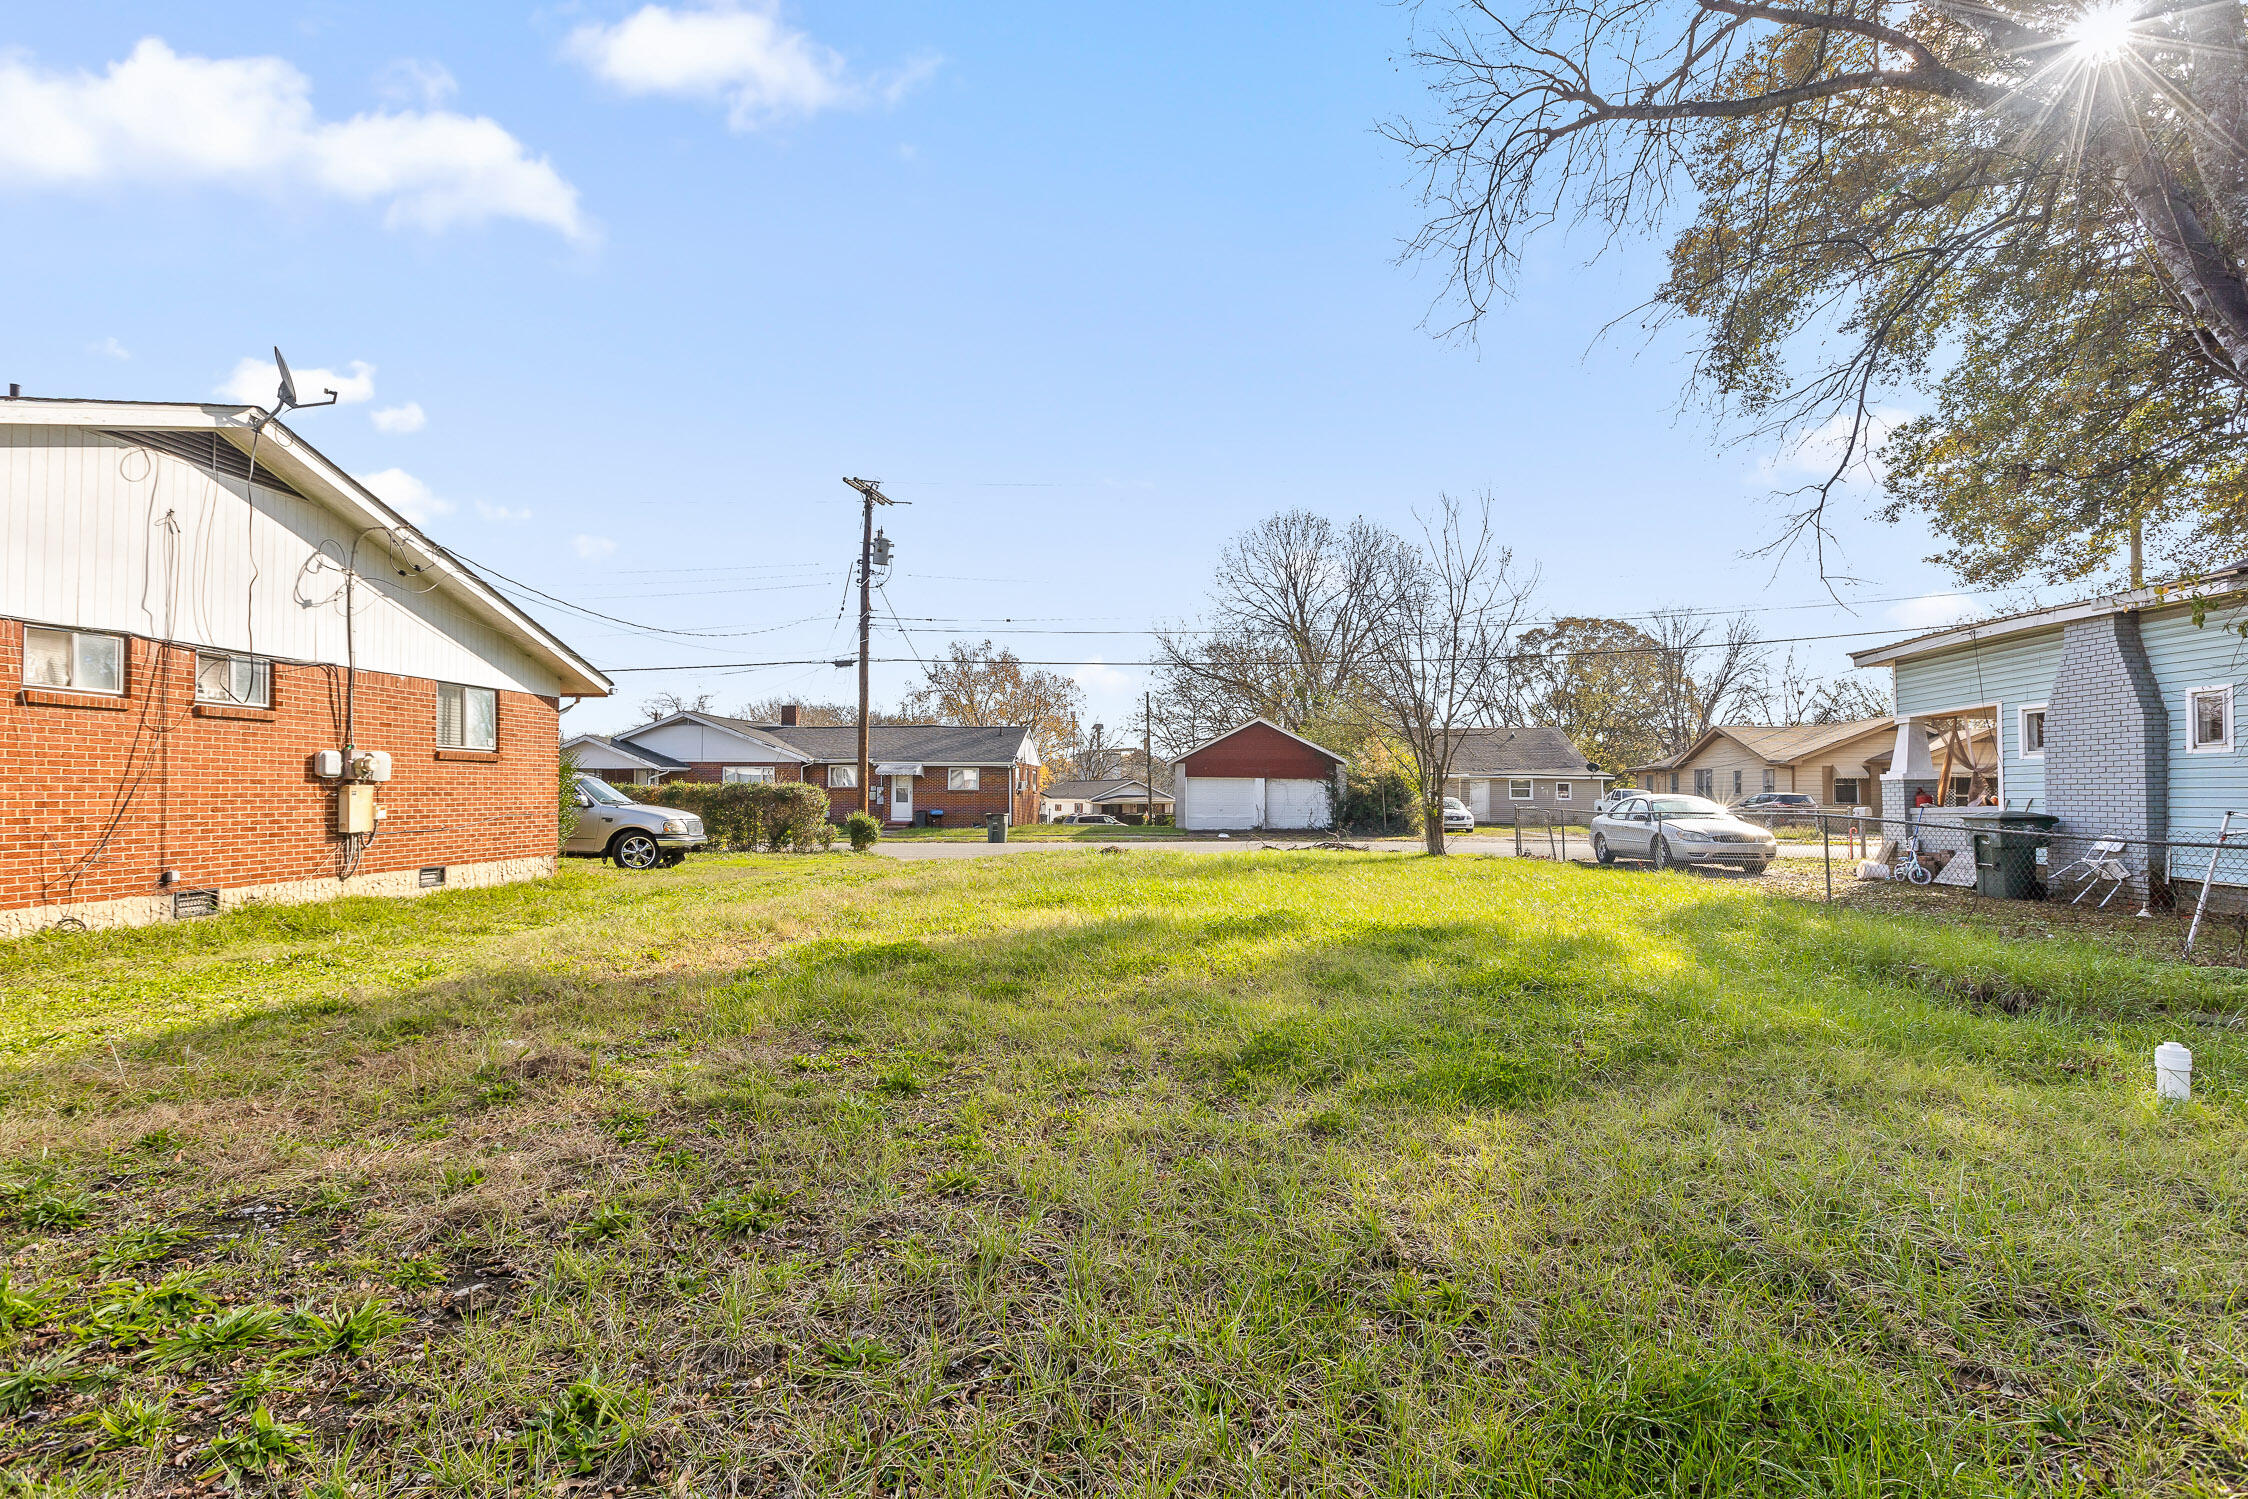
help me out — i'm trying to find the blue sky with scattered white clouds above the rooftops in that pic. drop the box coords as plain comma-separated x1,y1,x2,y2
0,0,2005,728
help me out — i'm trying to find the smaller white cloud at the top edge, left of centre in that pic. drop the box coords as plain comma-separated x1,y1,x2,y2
562,0,940,130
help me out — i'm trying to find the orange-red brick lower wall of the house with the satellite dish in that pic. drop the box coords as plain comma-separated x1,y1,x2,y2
0,620,560,910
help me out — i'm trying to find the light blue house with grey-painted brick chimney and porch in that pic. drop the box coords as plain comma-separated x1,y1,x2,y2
1852,564,2248,881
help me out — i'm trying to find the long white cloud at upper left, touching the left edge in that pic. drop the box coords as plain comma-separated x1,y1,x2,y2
0,36,589,238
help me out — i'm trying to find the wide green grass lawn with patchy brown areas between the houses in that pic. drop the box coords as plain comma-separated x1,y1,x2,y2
0,850,2248,1499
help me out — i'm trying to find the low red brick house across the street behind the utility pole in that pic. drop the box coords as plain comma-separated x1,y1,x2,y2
564,708,1039,827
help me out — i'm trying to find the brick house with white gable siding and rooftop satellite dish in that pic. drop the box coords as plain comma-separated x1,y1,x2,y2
0,398,609,935
